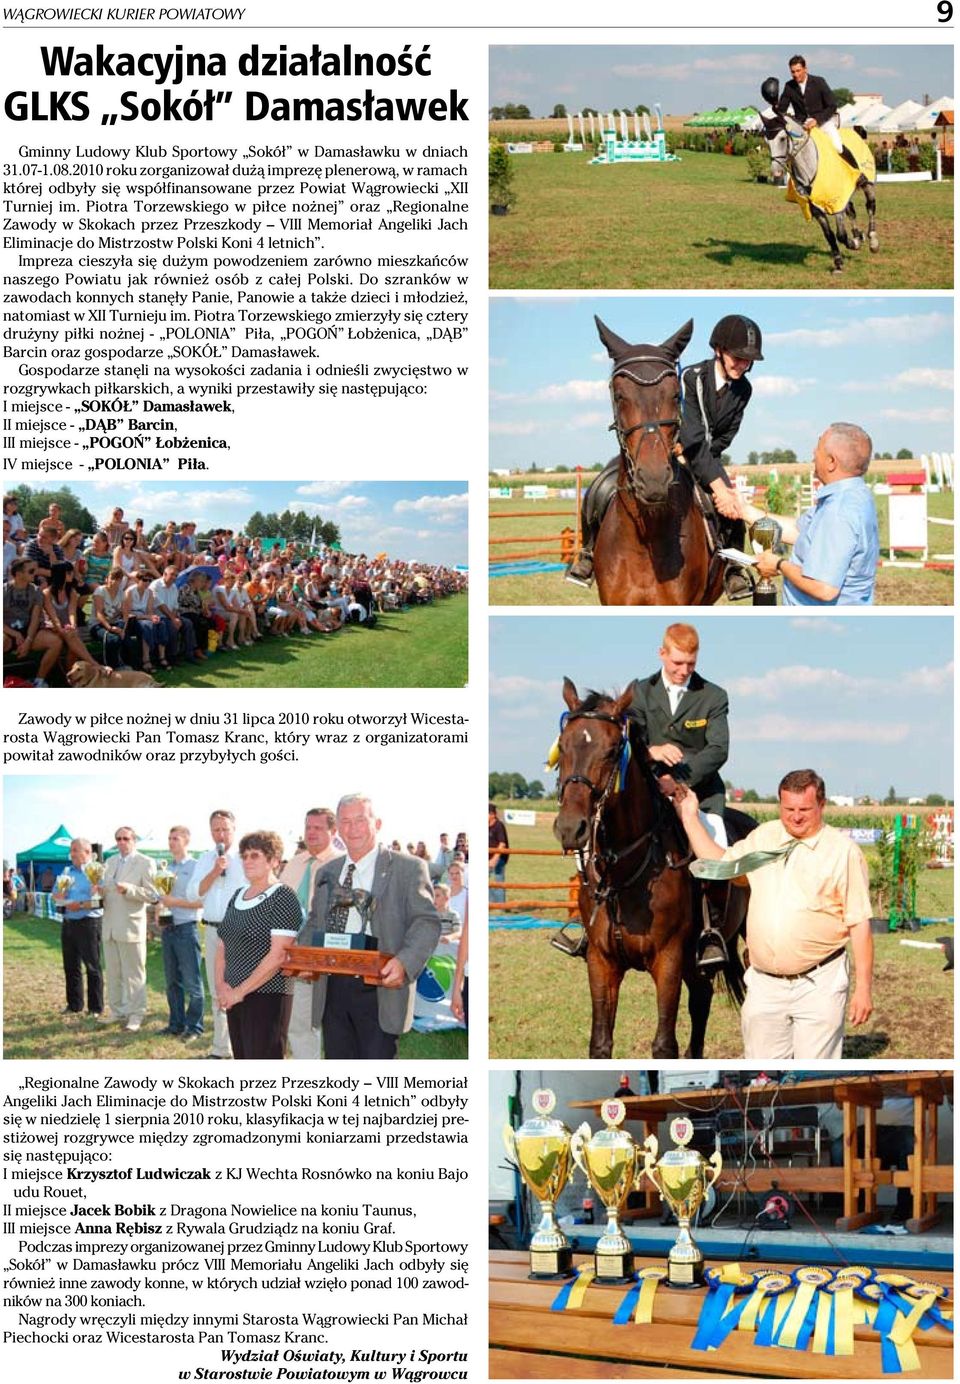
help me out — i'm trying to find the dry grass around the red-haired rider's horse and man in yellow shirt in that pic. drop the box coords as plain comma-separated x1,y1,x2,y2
490,804,953,1062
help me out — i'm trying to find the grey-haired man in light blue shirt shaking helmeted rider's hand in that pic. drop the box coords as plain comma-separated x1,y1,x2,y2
744,424,880,606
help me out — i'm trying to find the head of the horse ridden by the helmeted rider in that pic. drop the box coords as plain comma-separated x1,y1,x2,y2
593,317,693,505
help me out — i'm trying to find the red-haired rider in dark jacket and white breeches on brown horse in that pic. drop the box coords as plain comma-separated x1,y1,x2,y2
627,624,730,972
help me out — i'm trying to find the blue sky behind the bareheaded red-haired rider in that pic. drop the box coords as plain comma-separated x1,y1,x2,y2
490,612,953,797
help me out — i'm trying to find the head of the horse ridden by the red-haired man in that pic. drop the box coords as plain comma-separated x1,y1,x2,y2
553,678,634,851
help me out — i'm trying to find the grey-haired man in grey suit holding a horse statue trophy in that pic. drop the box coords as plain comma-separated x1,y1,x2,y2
300,793,440,1059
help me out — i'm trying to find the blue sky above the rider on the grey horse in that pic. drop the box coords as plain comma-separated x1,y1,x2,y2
490,39,953,116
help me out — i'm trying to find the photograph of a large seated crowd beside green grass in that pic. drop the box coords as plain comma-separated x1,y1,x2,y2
3,484,468,688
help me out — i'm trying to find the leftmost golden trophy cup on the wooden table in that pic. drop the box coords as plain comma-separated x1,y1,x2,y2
504,1091,574,1279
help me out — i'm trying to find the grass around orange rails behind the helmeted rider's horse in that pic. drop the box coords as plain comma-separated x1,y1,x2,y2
490,491,954,610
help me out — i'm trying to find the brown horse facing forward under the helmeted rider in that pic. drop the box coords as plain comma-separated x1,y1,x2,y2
593,317,723,605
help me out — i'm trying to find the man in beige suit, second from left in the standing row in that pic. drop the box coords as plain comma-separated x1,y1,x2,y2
100,826,159,1034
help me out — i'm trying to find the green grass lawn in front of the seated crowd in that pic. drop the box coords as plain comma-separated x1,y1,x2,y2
148,592,468,688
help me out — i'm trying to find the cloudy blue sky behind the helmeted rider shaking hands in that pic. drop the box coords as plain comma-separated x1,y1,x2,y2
490,293,953,468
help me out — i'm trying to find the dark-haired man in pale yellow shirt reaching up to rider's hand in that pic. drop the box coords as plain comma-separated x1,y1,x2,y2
674,770,873,1063
